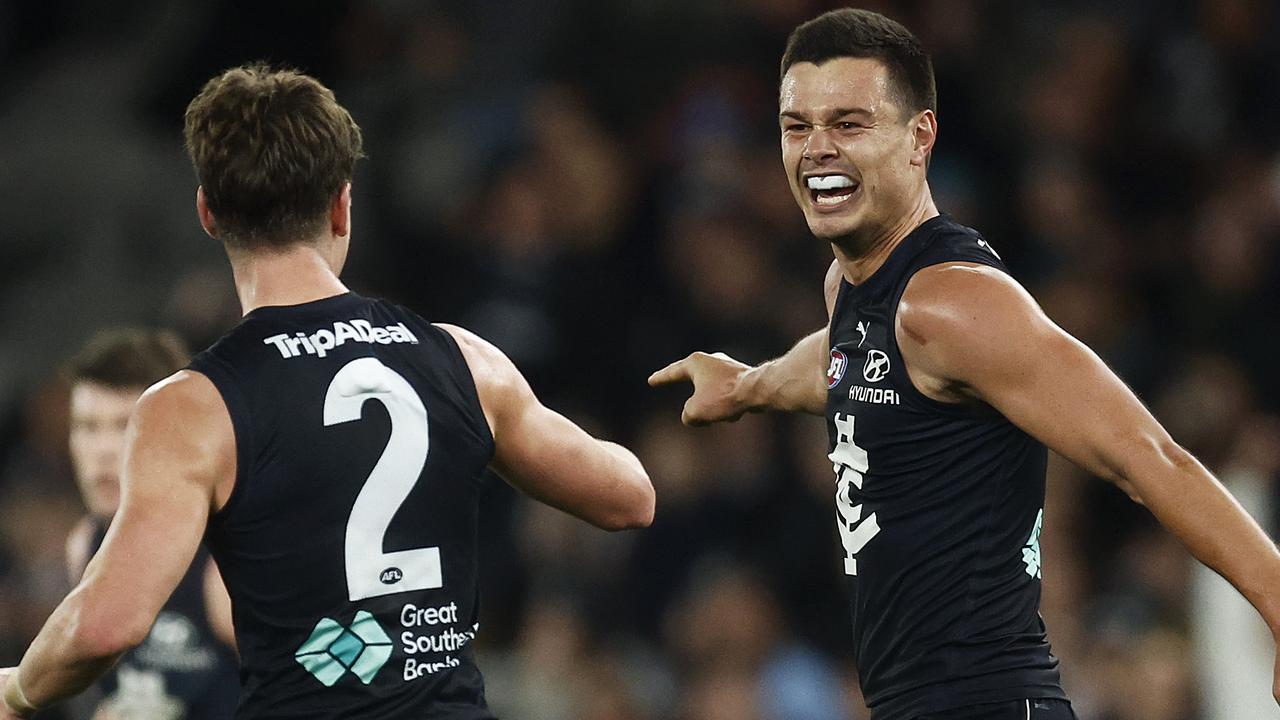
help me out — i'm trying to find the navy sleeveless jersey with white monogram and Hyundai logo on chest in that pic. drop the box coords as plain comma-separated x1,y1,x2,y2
827,217,1065,720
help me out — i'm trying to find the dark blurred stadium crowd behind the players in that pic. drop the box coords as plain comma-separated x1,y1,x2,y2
0,0,1280,720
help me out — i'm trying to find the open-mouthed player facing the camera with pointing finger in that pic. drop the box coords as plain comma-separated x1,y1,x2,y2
650,9,1280,720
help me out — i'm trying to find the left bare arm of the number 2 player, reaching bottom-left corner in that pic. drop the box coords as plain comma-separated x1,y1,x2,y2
0,372,234,717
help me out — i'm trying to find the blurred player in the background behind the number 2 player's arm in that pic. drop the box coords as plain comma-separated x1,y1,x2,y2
67,328,239,720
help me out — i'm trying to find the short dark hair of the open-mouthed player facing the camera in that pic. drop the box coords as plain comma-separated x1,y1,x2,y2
780,8,938,114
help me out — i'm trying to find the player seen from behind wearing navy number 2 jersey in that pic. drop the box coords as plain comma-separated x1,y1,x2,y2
0,65,654,720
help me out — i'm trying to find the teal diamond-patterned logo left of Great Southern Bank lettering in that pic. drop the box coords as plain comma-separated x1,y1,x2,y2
293,610,392,688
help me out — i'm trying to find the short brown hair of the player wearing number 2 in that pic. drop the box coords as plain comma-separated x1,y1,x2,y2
183,63,364,249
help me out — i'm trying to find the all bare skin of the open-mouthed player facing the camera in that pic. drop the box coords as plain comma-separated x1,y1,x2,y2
649,58,1280,701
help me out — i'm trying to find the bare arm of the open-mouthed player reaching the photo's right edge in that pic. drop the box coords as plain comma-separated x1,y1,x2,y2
897,264,1280,696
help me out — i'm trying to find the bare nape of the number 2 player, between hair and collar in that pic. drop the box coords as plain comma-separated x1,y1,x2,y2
230,243,347,315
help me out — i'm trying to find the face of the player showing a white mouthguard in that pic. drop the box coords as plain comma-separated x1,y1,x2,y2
778,58,936,255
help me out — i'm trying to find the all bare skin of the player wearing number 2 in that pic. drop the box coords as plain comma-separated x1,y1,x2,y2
0,178,654,720
